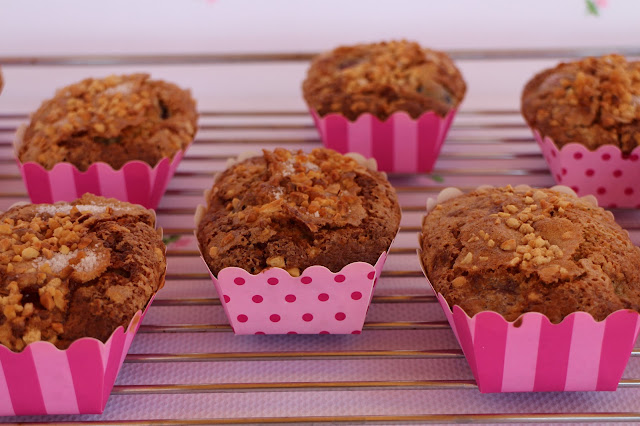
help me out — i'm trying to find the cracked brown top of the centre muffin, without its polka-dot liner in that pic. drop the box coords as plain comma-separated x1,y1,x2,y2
196,148,400,276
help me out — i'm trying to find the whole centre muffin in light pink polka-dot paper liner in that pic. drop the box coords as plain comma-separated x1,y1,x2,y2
196,148,400,334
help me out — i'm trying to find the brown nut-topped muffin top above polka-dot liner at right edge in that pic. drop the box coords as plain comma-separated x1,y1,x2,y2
522,55,640,154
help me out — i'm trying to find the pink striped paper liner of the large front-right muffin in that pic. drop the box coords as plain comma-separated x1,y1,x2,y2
422,186,640,393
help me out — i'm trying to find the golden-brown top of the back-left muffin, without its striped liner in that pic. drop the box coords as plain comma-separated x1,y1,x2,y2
17,74,198,171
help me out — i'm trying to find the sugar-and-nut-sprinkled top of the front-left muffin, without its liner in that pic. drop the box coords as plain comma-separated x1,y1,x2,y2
0,194,166,351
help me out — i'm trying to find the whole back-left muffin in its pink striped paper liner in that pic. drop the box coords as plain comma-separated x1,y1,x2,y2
14,74,197,209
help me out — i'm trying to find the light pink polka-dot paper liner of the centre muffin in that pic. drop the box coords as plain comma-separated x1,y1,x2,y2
195,150,397,334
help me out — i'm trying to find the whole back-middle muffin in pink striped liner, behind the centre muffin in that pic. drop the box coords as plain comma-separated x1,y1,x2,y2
302,41,466,173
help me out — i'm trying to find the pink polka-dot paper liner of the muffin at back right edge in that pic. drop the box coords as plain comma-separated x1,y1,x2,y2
533,130,640,208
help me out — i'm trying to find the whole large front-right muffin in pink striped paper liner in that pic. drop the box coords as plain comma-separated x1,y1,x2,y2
420,186,640,393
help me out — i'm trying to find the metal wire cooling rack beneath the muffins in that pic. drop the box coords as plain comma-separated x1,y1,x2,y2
0,49,640,425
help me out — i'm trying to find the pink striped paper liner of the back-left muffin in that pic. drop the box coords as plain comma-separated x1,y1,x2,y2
16,126,186,209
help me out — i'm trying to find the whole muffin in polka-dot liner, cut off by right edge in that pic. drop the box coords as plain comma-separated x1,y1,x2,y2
522,55,640,208
